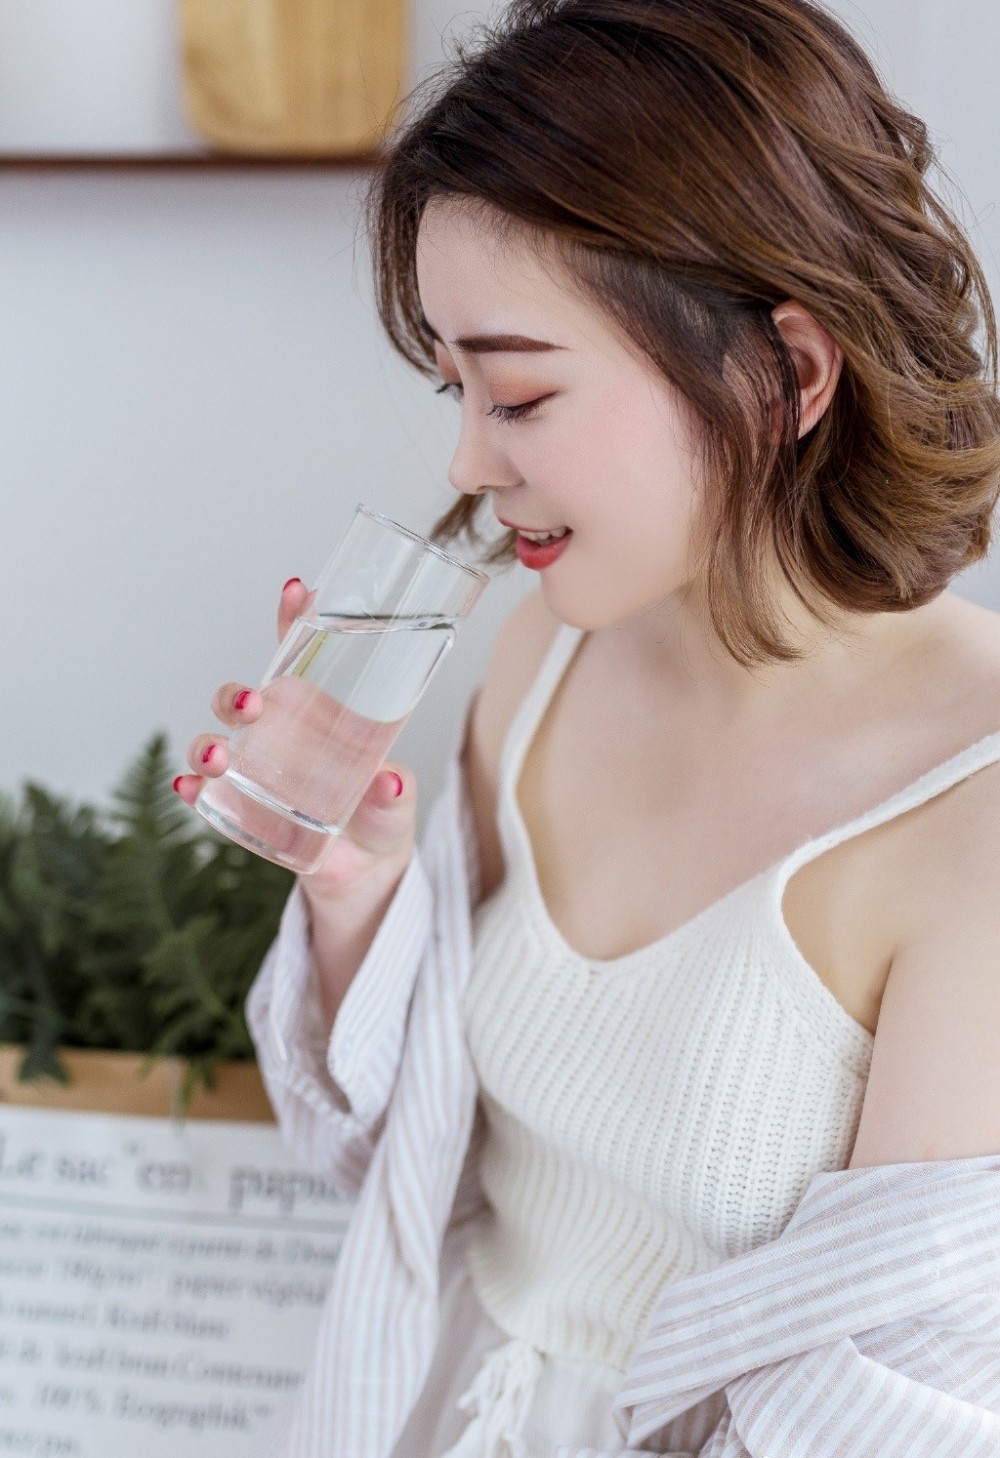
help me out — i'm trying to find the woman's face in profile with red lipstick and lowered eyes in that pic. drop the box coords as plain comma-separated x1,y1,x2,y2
417,198,698,630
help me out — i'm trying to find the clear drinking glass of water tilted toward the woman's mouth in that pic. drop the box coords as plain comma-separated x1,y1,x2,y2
195,504,490,875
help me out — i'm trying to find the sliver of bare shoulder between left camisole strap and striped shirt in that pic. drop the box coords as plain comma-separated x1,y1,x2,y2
462,589,561,897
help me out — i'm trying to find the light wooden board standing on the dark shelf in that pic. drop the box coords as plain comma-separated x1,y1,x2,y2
179,0,404,157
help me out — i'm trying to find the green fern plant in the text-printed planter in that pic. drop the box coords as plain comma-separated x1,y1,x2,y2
0,733,294,1110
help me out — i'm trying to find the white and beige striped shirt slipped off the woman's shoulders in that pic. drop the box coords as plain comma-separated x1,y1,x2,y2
246,696,1000,1458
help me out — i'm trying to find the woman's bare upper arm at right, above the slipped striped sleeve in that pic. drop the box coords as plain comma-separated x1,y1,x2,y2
848,767,1000,1168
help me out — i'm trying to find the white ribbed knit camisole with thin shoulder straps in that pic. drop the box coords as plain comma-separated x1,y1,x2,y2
464,624,1000,1372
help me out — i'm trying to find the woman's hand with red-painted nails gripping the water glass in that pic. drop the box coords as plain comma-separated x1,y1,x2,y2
173,577,417,905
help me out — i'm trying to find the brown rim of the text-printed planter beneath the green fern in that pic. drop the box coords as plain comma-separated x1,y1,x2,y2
0,1042,274,1124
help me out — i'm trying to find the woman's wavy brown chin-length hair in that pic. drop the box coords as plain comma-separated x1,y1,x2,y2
363,0,1000,668
